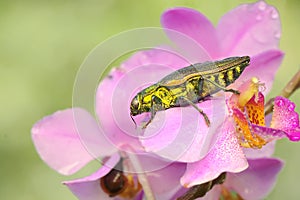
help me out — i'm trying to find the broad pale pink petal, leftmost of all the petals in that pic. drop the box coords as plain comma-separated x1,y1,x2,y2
31,108,116,175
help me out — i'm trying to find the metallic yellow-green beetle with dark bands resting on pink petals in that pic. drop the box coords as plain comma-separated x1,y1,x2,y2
130,56,250,128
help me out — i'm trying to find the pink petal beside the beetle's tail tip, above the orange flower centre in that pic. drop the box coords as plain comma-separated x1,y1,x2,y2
232,50,284,94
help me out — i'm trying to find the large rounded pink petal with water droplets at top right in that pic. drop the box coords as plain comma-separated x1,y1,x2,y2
217,1,281,56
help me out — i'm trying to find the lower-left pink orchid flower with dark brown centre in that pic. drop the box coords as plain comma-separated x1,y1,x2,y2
32,108,186,200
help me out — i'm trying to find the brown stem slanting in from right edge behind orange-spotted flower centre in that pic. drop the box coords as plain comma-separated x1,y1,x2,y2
265,70,300,115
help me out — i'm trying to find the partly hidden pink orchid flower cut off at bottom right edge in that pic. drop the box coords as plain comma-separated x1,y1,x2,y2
173,158,283,200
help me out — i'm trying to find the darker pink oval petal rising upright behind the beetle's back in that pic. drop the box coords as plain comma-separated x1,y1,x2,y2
161,8,218,59
